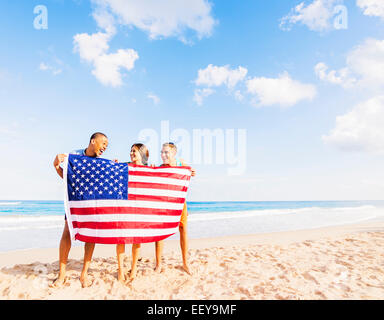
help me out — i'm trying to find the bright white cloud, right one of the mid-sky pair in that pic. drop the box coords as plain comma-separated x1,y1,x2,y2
246,72,316,107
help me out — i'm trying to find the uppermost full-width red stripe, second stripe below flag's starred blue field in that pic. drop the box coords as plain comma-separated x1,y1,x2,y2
71,207,182,216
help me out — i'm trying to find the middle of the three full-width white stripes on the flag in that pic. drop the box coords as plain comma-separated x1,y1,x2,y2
71,214,180,222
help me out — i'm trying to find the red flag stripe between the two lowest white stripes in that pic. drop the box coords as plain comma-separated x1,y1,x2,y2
72,221,179,230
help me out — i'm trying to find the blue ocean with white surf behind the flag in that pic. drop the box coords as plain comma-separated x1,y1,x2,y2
0,200,384,252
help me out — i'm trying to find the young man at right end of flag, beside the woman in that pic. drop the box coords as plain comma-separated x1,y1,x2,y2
155,142,196,274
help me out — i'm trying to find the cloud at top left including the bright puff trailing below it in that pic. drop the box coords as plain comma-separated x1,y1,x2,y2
74,0,216,86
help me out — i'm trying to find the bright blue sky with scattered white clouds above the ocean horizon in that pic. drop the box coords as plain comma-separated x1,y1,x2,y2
0,0,384,201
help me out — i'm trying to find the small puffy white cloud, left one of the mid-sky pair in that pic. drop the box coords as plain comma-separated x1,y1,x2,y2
195,64,248,88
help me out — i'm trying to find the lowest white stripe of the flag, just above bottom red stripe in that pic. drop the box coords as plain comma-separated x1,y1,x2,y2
78,227,179,238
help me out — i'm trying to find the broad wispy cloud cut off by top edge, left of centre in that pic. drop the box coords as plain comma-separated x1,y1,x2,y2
93,0,216,41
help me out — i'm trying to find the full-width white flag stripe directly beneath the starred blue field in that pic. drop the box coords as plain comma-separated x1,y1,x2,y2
69,200,184,210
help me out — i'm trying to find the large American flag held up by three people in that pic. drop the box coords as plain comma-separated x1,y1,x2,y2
64,155,191,244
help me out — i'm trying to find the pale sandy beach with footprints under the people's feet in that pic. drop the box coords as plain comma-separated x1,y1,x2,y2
0,222,384,300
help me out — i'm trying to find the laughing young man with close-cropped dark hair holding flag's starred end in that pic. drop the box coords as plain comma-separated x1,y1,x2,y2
52,132,108,287
